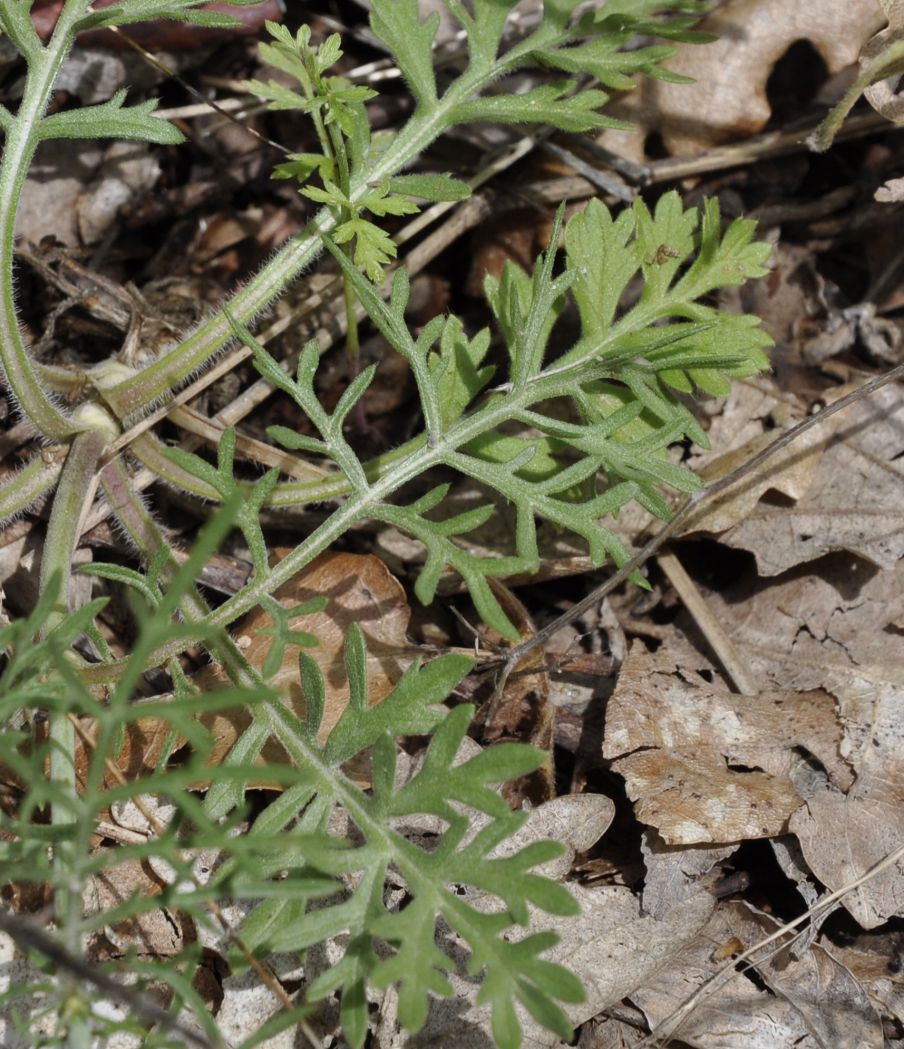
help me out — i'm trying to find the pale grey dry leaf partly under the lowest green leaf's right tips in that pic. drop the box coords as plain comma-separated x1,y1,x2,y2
402,885,713,1049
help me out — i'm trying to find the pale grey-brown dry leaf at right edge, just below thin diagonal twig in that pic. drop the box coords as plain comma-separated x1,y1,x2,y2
721,384,904,576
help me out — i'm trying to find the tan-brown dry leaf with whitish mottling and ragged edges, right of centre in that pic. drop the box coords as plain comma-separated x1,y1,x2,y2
603,635,851,844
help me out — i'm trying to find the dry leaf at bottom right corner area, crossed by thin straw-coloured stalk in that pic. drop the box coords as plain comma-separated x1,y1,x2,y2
631,903,884,1049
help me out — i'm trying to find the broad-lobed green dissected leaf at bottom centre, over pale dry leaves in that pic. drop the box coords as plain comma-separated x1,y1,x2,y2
229,631,580,1044
